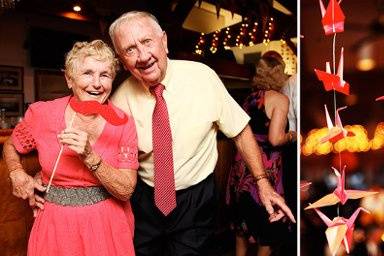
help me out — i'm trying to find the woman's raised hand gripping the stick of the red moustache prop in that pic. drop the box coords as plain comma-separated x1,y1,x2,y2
57,128,92,157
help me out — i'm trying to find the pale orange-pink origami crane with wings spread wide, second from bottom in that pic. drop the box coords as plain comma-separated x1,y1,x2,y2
305,166,377,210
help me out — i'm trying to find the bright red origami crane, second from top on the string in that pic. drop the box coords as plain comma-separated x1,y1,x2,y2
315,47,349,95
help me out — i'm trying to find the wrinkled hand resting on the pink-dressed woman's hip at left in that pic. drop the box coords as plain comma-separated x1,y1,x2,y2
9,169,45,217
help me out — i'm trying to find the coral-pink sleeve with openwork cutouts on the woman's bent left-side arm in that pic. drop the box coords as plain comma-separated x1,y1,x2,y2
11,102,41,154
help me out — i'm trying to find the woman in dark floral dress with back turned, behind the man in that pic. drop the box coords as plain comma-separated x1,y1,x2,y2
227,57,296,256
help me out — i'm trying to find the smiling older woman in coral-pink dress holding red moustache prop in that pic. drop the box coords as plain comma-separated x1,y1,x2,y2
4,40,138,256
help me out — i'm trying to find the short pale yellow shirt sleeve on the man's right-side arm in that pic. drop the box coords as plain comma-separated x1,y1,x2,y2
211,67,250,138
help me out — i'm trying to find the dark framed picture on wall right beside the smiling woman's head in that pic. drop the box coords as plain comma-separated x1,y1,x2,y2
35,70,72,100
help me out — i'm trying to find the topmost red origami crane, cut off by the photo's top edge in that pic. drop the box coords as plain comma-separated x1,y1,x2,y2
319,0,345,36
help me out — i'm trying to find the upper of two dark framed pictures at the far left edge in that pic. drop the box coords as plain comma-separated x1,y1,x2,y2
0,65,23,92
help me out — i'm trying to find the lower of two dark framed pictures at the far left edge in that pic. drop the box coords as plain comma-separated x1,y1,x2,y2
0,93,24,117
